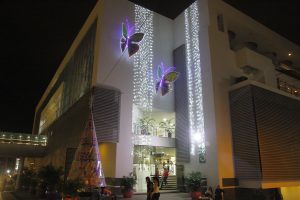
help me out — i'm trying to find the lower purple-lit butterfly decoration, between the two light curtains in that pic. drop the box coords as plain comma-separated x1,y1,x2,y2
155,63,180,96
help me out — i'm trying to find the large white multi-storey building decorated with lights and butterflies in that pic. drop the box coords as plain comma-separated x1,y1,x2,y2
30,0,300,199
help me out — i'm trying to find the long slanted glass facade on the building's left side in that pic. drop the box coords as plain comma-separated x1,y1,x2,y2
39,21,97,133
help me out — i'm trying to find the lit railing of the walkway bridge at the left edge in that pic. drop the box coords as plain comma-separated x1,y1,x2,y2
0,132,48,146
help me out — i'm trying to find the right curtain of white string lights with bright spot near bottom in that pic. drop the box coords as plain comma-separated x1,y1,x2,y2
184,1,205,158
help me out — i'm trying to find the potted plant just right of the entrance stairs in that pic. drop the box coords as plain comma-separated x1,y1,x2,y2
186,172,202,200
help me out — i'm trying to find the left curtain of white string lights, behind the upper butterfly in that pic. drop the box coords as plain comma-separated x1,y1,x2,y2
133,5,154,111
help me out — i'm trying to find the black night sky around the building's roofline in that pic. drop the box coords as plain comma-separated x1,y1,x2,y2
0,0,300,133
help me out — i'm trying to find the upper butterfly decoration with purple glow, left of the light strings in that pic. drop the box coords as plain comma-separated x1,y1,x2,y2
120,21,145,57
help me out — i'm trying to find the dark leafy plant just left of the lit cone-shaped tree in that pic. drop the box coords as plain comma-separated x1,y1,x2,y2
38,165,63,199
